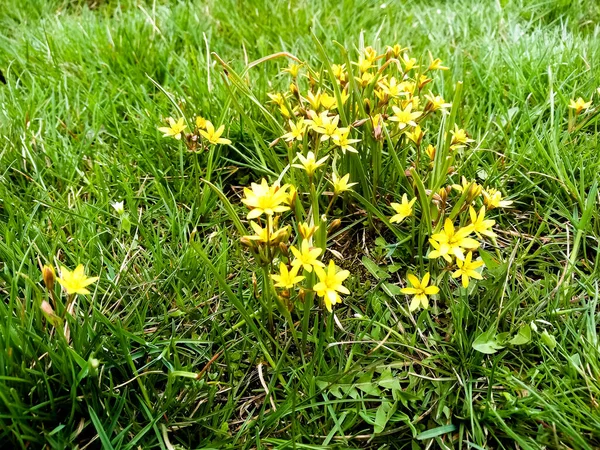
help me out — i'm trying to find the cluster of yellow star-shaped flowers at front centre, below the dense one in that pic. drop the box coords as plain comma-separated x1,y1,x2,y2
241,176,352,312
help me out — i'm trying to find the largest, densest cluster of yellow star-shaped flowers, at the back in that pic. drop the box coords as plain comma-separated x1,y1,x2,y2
268,45,464,193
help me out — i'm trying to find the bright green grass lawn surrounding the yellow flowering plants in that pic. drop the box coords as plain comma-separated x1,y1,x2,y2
0,0,600,449
